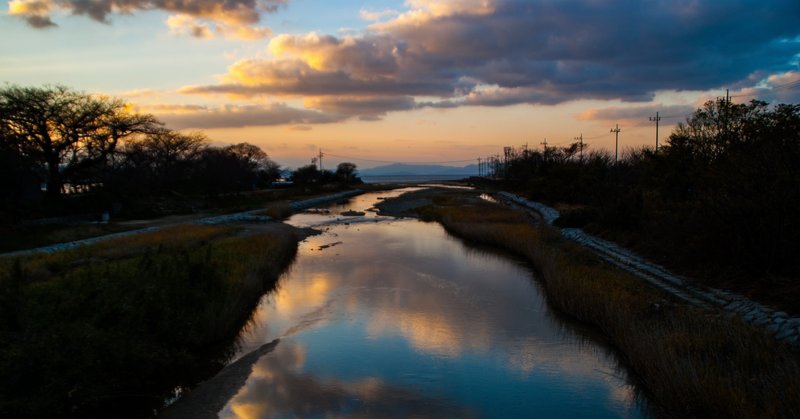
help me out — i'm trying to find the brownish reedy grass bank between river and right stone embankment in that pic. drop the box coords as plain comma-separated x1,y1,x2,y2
419,193,800,418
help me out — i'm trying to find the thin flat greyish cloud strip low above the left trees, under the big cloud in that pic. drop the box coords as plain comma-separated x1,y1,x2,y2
152,103,345,129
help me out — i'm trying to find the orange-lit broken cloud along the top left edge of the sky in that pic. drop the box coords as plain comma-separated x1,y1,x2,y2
8,0,289,39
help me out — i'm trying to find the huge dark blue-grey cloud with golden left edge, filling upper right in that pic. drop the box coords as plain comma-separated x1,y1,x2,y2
184,0,800,113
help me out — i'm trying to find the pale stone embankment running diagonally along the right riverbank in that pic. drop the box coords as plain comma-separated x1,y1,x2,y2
497,192,800,346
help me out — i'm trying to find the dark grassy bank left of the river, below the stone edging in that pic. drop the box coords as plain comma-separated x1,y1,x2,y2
0,226,298,418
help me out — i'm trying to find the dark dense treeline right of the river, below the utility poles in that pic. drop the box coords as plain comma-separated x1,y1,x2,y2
498,100,800,298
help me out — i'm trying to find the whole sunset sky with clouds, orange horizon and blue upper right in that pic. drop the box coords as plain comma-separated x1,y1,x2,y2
0,0,800,168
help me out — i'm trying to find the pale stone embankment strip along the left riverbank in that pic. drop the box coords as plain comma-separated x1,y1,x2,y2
0,189,364,257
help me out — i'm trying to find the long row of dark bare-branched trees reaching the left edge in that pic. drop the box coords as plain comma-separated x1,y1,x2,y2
0,86,280,218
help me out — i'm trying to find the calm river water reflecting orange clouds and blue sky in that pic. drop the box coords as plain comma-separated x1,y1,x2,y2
220,192,645,418
